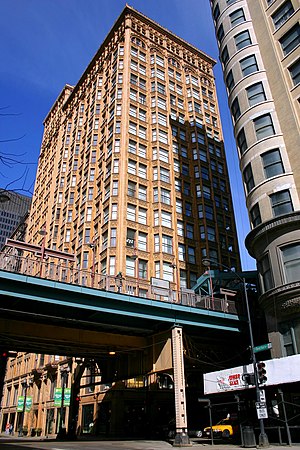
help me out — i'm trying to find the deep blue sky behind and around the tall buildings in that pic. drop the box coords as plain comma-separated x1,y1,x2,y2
0,0,255,270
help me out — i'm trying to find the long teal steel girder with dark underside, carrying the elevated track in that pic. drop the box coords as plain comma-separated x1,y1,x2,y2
0,271,242,334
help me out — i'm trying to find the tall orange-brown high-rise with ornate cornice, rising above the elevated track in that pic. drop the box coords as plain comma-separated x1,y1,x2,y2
28,6,240,296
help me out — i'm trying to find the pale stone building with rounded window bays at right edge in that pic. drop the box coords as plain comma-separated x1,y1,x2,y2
211,0,300,358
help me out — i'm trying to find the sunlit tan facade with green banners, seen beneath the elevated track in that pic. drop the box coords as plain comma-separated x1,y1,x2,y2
0,353,111,436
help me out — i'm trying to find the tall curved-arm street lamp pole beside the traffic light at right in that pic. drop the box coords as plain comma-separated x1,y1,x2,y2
202,258,269,447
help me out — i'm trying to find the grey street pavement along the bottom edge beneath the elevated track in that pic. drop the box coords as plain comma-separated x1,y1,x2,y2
0,434,300,450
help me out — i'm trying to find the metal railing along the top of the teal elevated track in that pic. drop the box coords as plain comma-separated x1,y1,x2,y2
0,253,237,314
